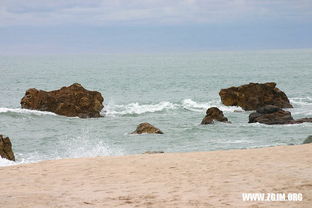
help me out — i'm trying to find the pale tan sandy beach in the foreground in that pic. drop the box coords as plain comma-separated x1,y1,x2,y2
0,144,312,208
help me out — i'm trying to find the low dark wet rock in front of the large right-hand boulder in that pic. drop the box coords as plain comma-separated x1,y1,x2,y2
248,105,312,125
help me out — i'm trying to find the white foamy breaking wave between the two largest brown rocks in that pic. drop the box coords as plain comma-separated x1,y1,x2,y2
102,99,242,116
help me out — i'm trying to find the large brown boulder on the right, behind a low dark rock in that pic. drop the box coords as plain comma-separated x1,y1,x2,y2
219,82,292,110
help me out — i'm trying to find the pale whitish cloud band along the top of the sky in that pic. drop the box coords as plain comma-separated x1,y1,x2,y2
0,0,312,26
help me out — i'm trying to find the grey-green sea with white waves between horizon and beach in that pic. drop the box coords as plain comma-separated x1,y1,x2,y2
0,50,312,165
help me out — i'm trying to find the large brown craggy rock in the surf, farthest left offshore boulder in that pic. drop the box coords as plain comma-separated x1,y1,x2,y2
21,83,104,118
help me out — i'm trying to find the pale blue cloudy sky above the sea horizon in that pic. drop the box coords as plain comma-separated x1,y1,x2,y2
0,0,312,55
